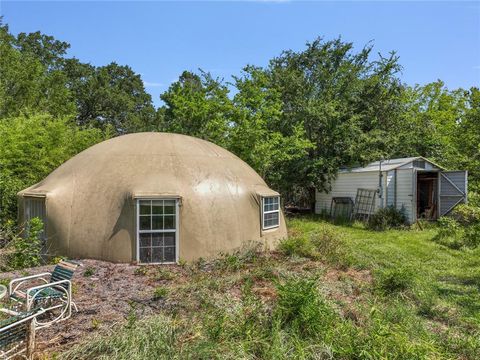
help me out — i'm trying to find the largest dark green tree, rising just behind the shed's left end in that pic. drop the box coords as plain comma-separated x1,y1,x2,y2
265,38,403,201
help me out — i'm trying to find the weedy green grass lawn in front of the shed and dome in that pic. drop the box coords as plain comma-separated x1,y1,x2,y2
60,217,480,360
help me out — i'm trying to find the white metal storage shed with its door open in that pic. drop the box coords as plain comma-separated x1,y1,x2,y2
315,156,468,223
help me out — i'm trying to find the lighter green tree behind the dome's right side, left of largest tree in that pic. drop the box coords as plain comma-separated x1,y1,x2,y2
229,66,313,199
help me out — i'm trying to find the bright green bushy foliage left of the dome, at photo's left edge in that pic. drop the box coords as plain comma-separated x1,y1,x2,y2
0,114,105,221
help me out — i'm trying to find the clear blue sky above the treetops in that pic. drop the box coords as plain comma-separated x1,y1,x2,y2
0,0,480,105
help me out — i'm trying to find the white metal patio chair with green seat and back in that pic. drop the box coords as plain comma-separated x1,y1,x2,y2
8,261,79,328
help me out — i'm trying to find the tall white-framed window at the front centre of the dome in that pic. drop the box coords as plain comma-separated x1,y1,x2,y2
137,199,178,264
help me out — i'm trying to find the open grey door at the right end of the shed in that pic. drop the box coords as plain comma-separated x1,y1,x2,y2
439,171,467,216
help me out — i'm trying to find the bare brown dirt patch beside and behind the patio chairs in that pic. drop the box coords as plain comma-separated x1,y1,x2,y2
0,260,189,357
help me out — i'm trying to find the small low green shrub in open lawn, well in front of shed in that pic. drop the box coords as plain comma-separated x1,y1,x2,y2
375,267,415,294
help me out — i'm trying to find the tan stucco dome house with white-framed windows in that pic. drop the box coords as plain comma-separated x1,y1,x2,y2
18,133,286,263
